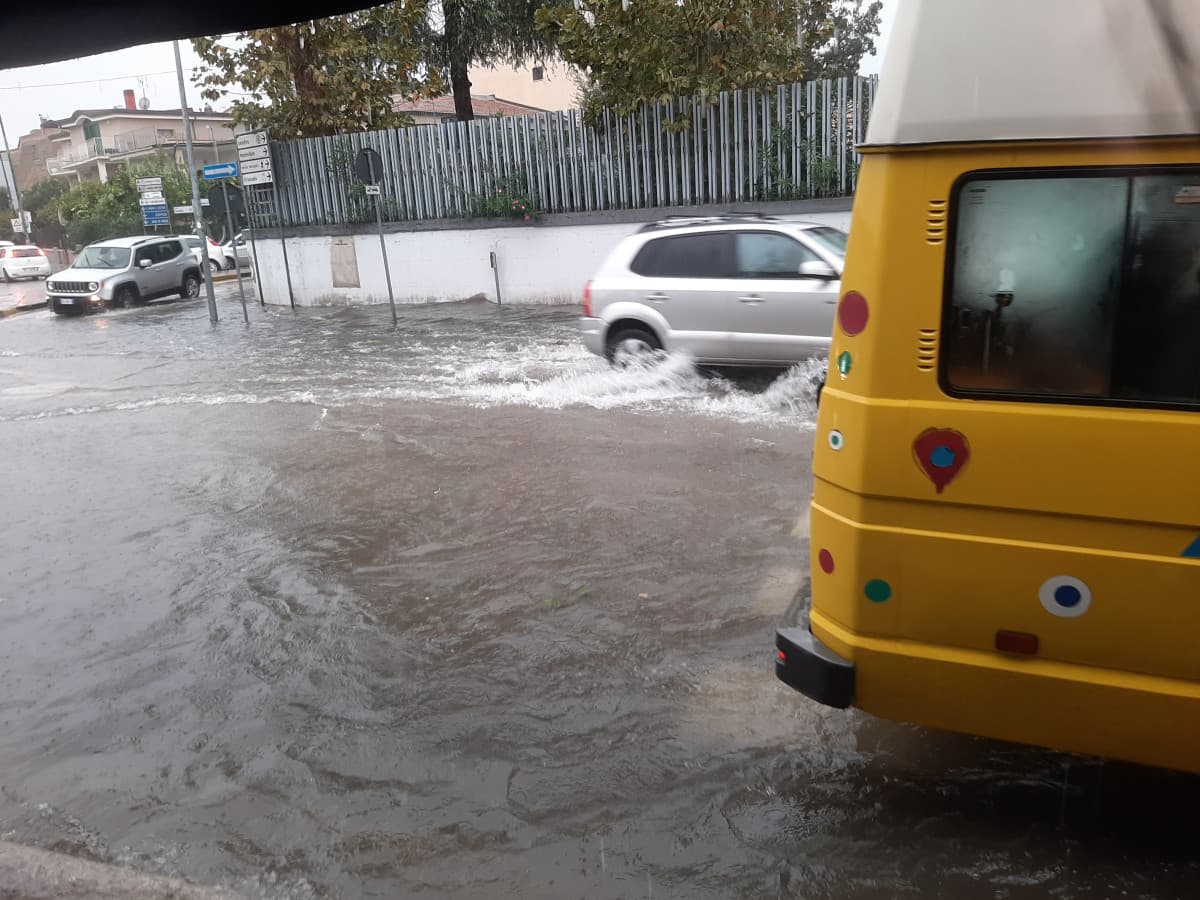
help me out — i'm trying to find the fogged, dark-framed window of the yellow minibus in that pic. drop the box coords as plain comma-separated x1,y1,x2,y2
941,168,1200,406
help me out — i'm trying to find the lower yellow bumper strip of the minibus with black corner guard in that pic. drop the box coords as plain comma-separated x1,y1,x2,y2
792,610,1200,774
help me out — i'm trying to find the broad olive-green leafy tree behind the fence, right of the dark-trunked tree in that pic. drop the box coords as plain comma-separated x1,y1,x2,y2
538,0,833,113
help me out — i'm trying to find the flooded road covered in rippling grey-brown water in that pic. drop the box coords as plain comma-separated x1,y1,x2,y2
0,302,1200,900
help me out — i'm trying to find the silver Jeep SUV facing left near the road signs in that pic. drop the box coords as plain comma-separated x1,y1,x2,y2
46,235,200,316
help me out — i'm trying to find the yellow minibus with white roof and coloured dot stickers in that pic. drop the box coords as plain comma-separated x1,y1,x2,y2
776,0,1200,772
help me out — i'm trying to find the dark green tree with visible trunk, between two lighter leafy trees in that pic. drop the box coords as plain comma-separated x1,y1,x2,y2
427,0,554,121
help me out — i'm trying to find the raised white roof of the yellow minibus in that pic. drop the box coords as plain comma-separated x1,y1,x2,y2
866,0,1200,145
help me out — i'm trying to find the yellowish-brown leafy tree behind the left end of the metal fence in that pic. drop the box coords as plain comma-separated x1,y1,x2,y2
192,0,442,139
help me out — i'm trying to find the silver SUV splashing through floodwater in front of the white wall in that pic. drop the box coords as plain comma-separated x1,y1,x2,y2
581,214,846,366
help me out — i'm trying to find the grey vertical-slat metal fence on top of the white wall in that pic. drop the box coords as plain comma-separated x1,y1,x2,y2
262,78,876,226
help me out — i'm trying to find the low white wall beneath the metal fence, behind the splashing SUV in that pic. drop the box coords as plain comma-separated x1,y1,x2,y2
256,210,850,306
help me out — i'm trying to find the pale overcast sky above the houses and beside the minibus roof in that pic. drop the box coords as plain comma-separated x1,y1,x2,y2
0,0,896,139
